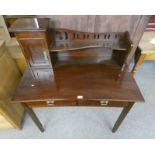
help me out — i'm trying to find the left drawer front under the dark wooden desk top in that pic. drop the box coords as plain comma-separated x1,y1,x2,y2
27,100,76,107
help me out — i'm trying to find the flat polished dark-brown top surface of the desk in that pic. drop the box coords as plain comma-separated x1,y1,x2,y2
13,64,144,102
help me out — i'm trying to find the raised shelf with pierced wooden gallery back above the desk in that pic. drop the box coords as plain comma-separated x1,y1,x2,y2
50,29,132,52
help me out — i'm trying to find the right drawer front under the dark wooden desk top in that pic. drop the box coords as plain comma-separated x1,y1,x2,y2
79,100,129,107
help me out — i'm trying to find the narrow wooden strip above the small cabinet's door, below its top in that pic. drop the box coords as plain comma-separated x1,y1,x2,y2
15,32,46,39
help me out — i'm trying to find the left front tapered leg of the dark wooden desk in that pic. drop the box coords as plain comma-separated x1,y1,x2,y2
22,103,44,132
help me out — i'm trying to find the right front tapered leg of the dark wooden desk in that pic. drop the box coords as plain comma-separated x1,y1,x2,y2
112,103,134,132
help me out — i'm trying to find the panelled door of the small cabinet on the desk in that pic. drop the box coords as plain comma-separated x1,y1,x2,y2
20,39,50,67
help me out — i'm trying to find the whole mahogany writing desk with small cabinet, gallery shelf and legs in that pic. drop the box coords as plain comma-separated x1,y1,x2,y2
10,18,144,132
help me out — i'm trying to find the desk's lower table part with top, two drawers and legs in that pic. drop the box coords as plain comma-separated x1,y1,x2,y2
13,64,144,132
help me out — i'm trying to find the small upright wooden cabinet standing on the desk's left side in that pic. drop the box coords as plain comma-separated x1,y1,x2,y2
9,18,52,68
